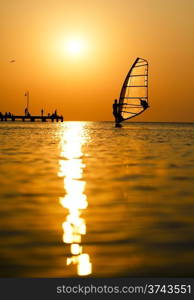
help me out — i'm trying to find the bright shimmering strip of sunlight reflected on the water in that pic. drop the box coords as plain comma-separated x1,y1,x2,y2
58,122,92,276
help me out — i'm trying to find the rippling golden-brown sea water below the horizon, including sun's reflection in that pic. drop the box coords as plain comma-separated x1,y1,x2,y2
0,122,194,277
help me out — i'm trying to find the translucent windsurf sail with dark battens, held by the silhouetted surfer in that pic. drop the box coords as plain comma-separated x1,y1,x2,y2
119,57,148,121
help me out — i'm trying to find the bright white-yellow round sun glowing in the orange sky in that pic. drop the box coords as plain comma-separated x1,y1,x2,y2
66,37,86,56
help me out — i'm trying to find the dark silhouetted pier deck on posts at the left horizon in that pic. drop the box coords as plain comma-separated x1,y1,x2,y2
0,115,63,122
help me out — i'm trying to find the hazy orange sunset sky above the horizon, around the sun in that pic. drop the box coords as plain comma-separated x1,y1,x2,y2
0,0,194,122
